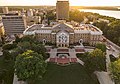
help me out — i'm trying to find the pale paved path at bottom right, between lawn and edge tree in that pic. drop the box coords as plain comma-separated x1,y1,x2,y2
95,71,115,84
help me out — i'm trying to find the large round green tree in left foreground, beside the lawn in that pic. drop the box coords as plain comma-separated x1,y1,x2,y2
15,50,46,84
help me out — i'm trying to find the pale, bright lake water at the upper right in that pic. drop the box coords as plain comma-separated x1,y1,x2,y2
79,9,120,19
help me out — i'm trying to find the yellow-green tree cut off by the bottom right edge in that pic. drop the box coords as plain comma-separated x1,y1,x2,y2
109,59,120,84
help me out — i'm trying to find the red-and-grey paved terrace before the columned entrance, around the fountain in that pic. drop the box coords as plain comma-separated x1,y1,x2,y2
46,48,84,65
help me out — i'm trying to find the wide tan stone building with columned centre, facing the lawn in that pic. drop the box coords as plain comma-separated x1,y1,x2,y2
24,22,103,47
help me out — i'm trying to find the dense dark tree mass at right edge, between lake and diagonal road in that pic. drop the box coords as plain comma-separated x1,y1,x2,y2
93,20,120,46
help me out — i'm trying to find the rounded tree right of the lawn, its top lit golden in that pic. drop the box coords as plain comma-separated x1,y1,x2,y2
85,49,106,72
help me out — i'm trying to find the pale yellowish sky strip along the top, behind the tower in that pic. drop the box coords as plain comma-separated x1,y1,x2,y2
0,0,120,6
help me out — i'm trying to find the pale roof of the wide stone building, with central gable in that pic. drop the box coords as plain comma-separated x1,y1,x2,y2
24,23,103,35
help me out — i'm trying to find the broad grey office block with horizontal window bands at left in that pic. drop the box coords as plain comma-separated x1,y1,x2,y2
2,15,26,35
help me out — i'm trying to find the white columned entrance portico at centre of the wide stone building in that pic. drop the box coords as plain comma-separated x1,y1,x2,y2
56,31,69,47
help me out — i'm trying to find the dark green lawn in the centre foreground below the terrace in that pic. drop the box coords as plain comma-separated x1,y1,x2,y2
36,64,98,84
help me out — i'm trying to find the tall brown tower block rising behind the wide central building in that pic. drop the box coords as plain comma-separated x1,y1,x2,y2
56,0,69,20
